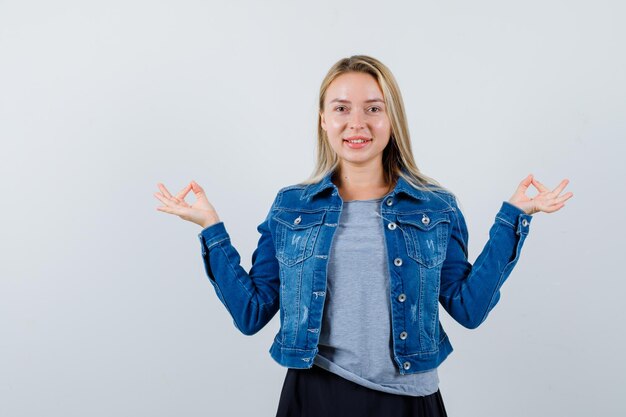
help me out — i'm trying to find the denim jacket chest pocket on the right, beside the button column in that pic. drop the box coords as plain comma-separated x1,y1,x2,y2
398,212,450,268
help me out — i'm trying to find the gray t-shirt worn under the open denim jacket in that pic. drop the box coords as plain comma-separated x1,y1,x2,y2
313,198,439,396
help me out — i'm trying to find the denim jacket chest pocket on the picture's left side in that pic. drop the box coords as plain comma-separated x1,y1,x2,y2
274,210,326,266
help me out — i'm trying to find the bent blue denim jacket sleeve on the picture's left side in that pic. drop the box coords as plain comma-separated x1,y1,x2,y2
198,194,280,335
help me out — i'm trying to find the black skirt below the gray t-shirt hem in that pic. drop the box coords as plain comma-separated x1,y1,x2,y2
276,365,447,417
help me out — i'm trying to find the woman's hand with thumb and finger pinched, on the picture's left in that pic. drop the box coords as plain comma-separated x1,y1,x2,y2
154,181,220,228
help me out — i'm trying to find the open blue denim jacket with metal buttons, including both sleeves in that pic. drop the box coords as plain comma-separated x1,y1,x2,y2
198,173,532,374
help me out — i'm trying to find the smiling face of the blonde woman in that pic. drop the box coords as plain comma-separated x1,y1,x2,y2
320,72,391,171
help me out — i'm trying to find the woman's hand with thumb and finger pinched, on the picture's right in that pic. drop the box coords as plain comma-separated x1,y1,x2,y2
509,174,574,214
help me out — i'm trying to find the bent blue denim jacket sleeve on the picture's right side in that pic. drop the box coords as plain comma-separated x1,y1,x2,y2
439,196,532,329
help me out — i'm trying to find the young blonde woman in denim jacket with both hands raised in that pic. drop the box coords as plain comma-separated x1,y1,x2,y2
155,55,573,417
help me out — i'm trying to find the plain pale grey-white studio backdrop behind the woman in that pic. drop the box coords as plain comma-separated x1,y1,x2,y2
0,0,626,417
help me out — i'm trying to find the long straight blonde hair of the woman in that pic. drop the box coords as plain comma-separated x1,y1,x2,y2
300,55,450,196
